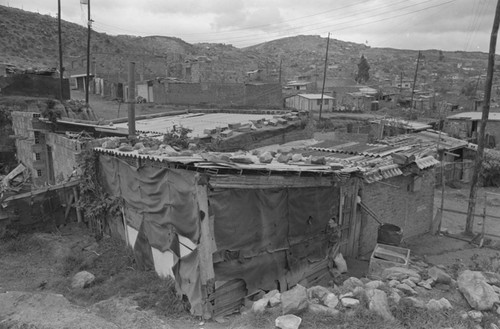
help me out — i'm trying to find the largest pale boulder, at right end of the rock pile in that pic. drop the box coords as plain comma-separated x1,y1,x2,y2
458,270,500,311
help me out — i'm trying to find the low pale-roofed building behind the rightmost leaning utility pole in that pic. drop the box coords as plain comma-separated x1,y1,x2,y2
445,112,500,149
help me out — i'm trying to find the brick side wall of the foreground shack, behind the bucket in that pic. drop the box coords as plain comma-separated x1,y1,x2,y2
358,169,435,257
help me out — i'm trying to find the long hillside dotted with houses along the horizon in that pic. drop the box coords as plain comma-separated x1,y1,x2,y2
0,6,487,92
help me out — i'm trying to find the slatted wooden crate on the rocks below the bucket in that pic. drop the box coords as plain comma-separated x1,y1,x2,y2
368,243,410,280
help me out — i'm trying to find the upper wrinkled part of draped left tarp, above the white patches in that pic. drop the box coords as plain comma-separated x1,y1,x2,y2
99,155,200,252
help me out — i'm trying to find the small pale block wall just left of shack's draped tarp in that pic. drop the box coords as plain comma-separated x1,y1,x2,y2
46,133,82,183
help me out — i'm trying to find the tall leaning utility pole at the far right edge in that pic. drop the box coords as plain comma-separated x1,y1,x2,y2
465,0,500,235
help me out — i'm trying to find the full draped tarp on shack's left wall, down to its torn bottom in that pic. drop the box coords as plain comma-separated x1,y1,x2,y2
99,155,202,315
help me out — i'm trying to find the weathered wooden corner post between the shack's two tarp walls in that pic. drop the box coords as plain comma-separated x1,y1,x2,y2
196,178,215,319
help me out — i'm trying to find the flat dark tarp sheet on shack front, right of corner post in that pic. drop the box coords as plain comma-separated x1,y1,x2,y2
209,186,339,293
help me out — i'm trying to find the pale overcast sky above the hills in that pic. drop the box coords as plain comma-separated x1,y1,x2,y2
0,0,496,52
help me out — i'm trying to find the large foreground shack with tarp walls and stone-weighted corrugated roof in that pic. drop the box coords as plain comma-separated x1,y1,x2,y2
95,131,436,316
